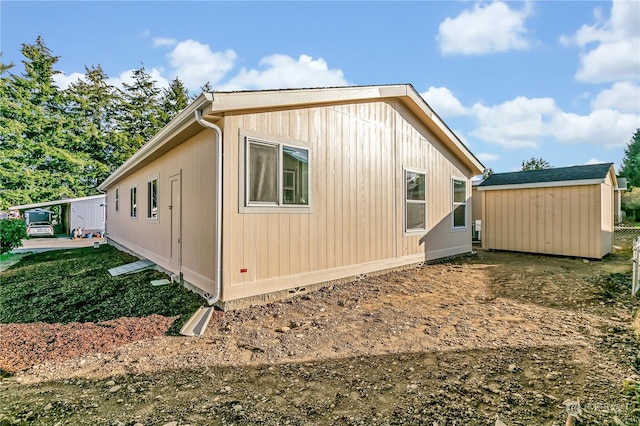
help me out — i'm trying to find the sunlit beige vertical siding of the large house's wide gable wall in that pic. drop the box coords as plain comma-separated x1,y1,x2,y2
222,102,471,300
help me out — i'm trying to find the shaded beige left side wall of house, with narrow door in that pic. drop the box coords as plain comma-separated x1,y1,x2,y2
107,130,215,291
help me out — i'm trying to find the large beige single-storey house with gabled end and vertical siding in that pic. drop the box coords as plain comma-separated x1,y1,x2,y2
100,85,483,309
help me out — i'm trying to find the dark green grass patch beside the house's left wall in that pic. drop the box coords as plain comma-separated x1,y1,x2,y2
0,245,204,332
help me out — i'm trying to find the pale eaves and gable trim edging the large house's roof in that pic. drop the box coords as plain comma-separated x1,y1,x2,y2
98,84,484,190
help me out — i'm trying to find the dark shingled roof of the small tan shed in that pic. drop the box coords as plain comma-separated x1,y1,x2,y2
478,163,616,190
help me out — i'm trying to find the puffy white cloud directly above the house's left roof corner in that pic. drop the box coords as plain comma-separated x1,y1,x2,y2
167,40,236,90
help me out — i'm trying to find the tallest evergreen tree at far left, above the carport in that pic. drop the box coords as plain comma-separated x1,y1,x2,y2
0,37,104,208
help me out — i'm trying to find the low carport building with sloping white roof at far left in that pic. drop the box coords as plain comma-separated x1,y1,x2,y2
10,194,106,235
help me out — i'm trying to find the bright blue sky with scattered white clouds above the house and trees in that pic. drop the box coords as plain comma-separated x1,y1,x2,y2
0,0,640,172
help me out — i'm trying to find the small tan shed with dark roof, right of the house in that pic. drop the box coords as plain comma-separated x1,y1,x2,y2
478,163,617,259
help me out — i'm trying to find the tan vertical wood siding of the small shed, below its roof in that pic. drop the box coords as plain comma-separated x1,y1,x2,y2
481,181,613,258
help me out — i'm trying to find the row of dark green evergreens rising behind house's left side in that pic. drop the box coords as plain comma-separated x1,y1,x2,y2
0,37,189,209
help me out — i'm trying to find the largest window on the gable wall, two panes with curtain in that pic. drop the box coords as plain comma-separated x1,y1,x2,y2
244,138,309,207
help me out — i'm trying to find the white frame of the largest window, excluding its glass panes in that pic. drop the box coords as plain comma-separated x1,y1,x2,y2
238,131,313,214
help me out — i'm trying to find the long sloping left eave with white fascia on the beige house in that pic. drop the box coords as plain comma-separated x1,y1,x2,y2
98,93,213,191
